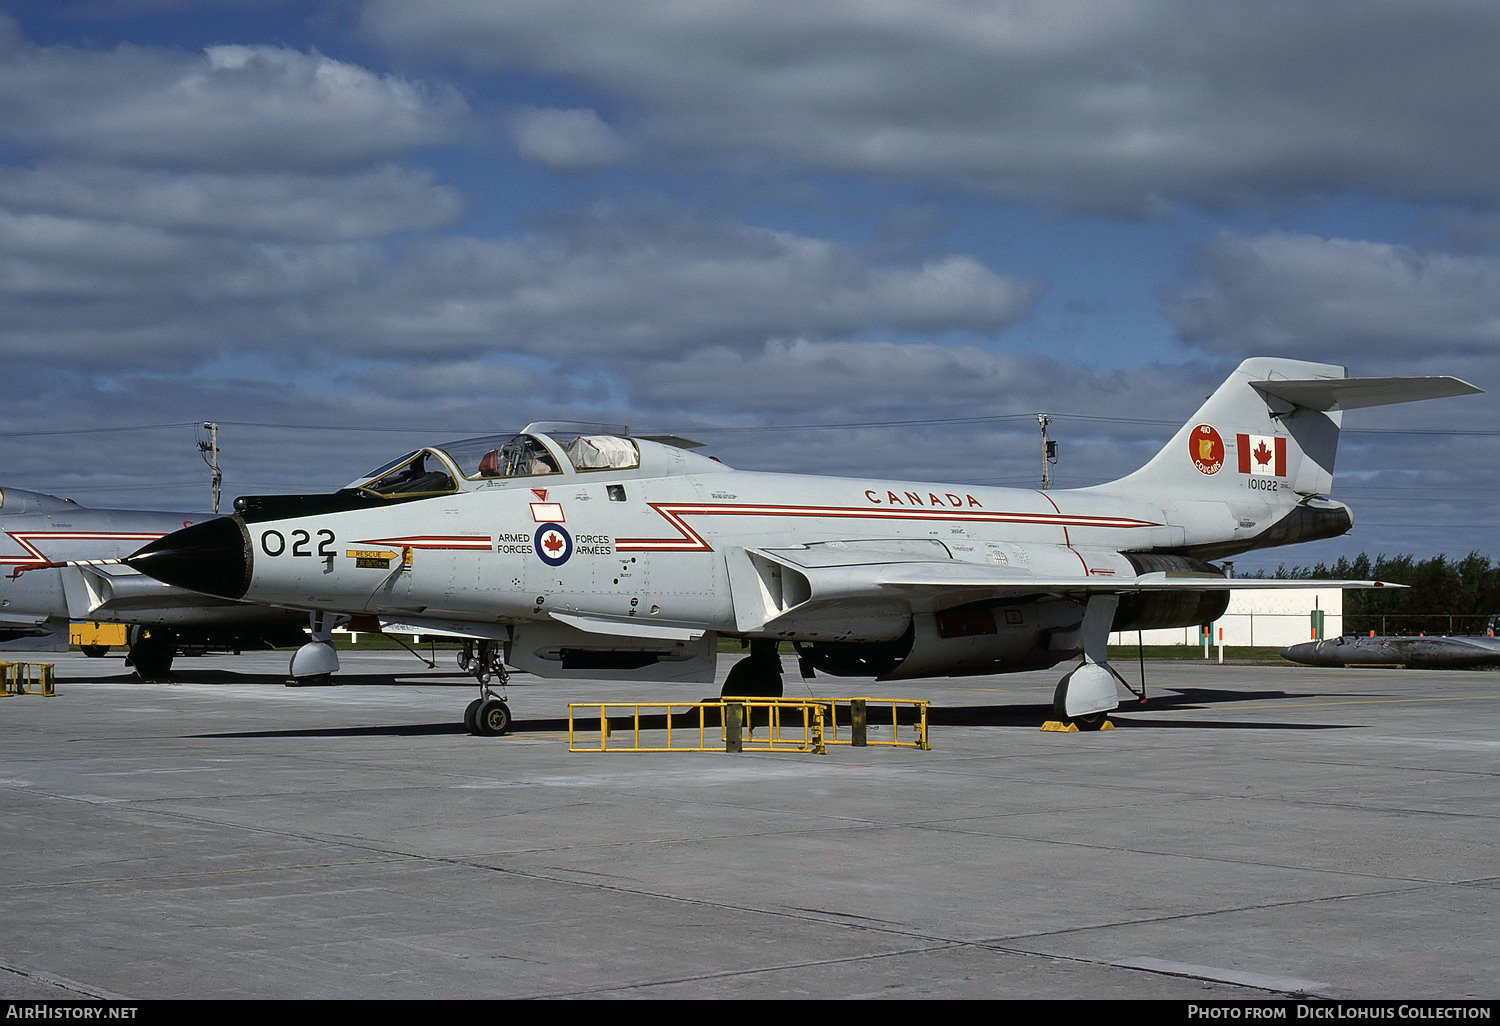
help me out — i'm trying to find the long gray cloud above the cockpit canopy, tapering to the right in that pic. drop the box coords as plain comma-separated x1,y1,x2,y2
292,204,1041,359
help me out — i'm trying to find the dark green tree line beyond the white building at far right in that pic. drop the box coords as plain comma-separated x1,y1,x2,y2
1260,552,1500,635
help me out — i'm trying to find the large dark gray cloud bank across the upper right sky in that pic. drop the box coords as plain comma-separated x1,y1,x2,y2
363,0,1500,213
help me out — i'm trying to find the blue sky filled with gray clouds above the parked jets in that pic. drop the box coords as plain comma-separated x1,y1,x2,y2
0,0,1500,572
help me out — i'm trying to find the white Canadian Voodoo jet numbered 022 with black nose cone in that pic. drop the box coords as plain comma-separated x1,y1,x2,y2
125,359,1479,734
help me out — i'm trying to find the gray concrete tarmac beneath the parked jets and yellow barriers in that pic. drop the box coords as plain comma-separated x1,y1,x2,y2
0,651,1500,1001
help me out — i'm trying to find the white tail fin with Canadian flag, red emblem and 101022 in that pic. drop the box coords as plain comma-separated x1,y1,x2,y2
1107,357,1481,507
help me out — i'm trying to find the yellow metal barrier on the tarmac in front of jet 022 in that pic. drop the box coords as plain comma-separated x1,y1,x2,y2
567,698,932,755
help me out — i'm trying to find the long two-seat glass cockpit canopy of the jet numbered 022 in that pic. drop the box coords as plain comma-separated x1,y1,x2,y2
348,429,641,498
